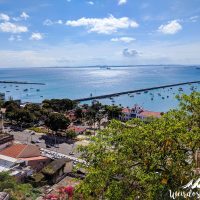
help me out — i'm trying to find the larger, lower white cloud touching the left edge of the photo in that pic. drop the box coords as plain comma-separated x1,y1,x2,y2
0,22,28,33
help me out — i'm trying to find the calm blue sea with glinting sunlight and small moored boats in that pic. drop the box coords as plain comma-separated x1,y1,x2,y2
0,66,200,111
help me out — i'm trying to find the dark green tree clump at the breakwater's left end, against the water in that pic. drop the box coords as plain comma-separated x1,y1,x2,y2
42,99,77,112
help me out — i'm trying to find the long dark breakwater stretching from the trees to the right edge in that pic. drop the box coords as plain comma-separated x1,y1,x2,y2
74,81,200,102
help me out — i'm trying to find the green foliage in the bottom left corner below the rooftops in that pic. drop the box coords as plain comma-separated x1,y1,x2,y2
0,172,39,200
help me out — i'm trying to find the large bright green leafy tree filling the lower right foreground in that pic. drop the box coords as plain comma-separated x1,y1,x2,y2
77,93,200,200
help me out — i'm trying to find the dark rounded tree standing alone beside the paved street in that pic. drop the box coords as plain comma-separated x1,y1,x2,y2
45,113,70,133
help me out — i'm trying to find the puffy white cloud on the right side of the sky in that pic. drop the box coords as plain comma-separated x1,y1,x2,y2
158,20,182,35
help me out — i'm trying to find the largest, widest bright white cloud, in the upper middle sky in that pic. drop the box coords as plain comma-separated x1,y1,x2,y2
66,15,139,34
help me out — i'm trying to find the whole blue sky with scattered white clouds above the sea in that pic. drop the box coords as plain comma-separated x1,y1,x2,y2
0,0,200,67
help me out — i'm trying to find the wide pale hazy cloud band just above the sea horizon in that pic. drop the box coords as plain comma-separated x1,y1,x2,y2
0,41,200,67
